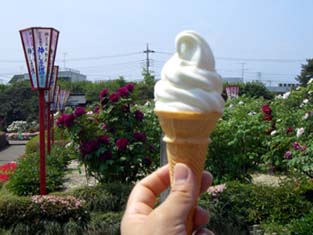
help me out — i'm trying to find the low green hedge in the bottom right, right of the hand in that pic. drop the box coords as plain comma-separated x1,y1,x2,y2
200,182,313,234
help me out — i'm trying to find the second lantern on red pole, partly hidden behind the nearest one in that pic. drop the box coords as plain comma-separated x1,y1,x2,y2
45,66,59,154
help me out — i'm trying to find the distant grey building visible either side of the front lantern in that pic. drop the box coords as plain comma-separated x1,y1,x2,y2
9,68,87,83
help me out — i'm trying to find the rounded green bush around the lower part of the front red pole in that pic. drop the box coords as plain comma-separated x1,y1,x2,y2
7,150,67,196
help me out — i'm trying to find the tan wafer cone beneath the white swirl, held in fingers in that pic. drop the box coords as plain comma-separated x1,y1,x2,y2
155,110,222,235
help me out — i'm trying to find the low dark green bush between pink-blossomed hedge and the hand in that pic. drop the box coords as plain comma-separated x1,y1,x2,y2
70,184,131,212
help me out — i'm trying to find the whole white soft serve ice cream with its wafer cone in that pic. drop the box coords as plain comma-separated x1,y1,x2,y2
154,31,224,235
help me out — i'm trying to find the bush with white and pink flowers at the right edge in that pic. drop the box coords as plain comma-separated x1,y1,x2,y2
263,82,313,174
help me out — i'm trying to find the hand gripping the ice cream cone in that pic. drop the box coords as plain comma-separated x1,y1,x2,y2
121,163,213,235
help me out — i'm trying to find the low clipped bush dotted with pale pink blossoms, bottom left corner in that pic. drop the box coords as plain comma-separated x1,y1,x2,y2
0,196,90,234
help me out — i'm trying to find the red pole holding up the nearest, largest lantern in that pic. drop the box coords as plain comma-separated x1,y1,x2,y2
39,89,46,195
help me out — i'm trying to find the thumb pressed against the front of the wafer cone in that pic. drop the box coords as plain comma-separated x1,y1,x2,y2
158,163,197,224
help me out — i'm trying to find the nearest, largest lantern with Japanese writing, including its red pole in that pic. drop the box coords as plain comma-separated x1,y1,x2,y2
20,27,59,195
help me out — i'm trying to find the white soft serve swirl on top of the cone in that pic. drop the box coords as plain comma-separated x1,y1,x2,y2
154,31,224,113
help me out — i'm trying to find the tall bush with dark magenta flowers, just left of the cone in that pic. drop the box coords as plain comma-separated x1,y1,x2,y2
57,83,159,182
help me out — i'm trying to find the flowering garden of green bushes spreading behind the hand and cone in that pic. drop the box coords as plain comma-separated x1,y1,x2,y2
0,76,313,235
